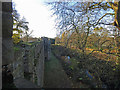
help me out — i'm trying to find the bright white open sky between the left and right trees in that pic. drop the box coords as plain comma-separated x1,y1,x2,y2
12,0,56,38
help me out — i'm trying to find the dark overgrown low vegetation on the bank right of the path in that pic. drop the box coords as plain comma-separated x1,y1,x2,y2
52,45,120,88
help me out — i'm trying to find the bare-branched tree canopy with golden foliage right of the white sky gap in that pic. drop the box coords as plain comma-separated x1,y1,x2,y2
48,1,120,52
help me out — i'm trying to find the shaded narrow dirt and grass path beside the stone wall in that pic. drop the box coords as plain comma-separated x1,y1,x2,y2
44,53,72,88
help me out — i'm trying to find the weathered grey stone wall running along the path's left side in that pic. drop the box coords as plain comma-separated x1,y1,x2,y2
13,38,51,87
